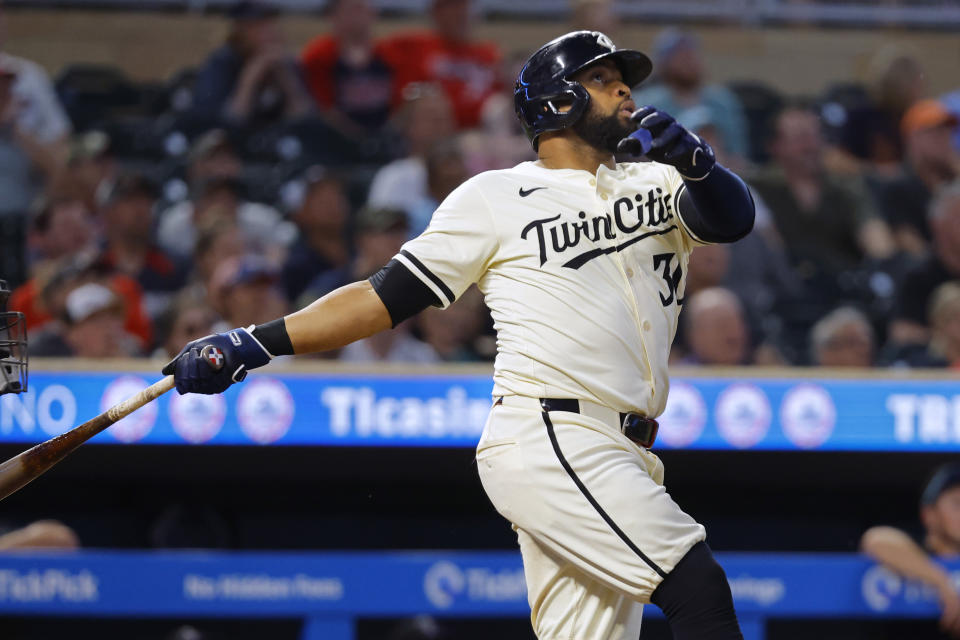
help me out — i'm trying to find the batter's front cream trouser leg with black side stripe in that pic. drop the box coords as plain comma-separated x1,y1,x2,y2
477,407,705,602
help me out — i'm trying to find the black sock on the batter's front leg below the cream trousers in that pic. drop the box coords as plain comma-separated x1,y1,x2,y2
650,542,743,640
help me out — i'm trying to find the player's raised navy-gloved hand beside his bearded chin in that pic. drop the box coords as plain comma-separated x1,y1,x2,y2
617,107,717,180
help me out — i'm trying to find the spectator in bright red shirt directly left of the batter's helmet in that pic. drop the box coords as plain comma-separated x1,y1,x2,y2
381,0,500,129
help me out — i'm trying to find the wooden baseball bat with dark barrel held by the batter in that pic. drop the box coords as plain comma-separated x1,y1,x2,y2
0,376,173,500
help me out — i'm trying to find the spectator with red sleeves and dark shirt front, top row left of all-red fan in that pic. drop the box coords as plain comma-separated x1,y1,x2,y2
301,0,393,134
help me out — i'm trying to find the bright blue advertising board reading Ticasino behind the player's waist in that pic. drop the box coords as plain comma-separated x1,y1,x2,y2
0,370,960,452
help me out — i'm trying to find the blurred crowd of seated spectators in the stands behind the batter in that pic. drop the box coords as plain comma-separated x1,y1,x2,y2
0,0,960,368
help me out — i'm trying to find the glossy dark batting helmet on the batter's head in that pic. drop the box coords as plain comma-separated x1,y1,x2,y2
513,31,653,149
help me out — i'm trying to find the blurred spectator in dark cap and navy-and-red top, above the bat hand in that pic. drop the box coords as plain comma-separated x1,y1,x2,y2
100,174,188,318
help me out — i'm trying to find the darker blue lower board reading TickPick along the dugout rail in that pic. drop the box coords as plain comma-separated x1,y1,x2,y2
0,551,960,640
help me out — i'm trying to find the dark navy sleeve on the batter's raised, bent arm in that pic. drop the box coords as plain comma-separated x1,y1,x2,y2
677,164,755,242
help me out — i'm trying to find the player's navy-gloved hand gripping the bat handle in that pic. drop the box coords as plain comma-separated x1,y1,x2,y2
162,325,273,395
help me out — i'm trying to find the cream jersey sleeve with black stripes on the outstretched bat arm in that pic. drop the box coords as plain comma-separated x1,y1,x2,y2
395,178,499,308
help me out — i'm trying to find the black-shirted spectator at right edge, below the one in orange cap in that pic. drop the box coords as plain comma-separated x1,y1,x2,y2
888,180,960,349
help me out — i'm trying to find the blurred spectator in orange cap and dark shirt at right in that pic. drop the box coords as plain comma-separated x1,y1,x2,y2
876,100,960,256
